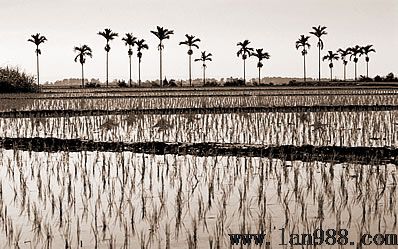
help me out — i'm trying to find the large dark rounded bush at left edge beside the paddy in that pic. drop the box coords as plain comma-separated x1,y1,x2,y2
0,67,39,93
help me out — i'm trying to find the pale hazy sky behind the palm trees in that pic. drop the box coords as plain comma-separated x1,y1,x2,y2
0,0,398,82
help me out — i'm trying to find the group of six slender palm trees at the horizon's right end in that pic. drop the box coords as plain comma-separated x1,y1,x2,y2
296,25,376,82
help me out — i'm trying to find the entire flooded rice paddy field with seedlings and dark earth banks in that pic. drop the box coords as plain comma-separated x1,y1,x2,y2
0,86,398,249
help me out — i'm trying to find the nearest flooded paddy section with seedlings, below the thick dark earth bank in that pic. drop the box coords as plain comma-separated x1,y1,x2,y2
0,149,398,248
